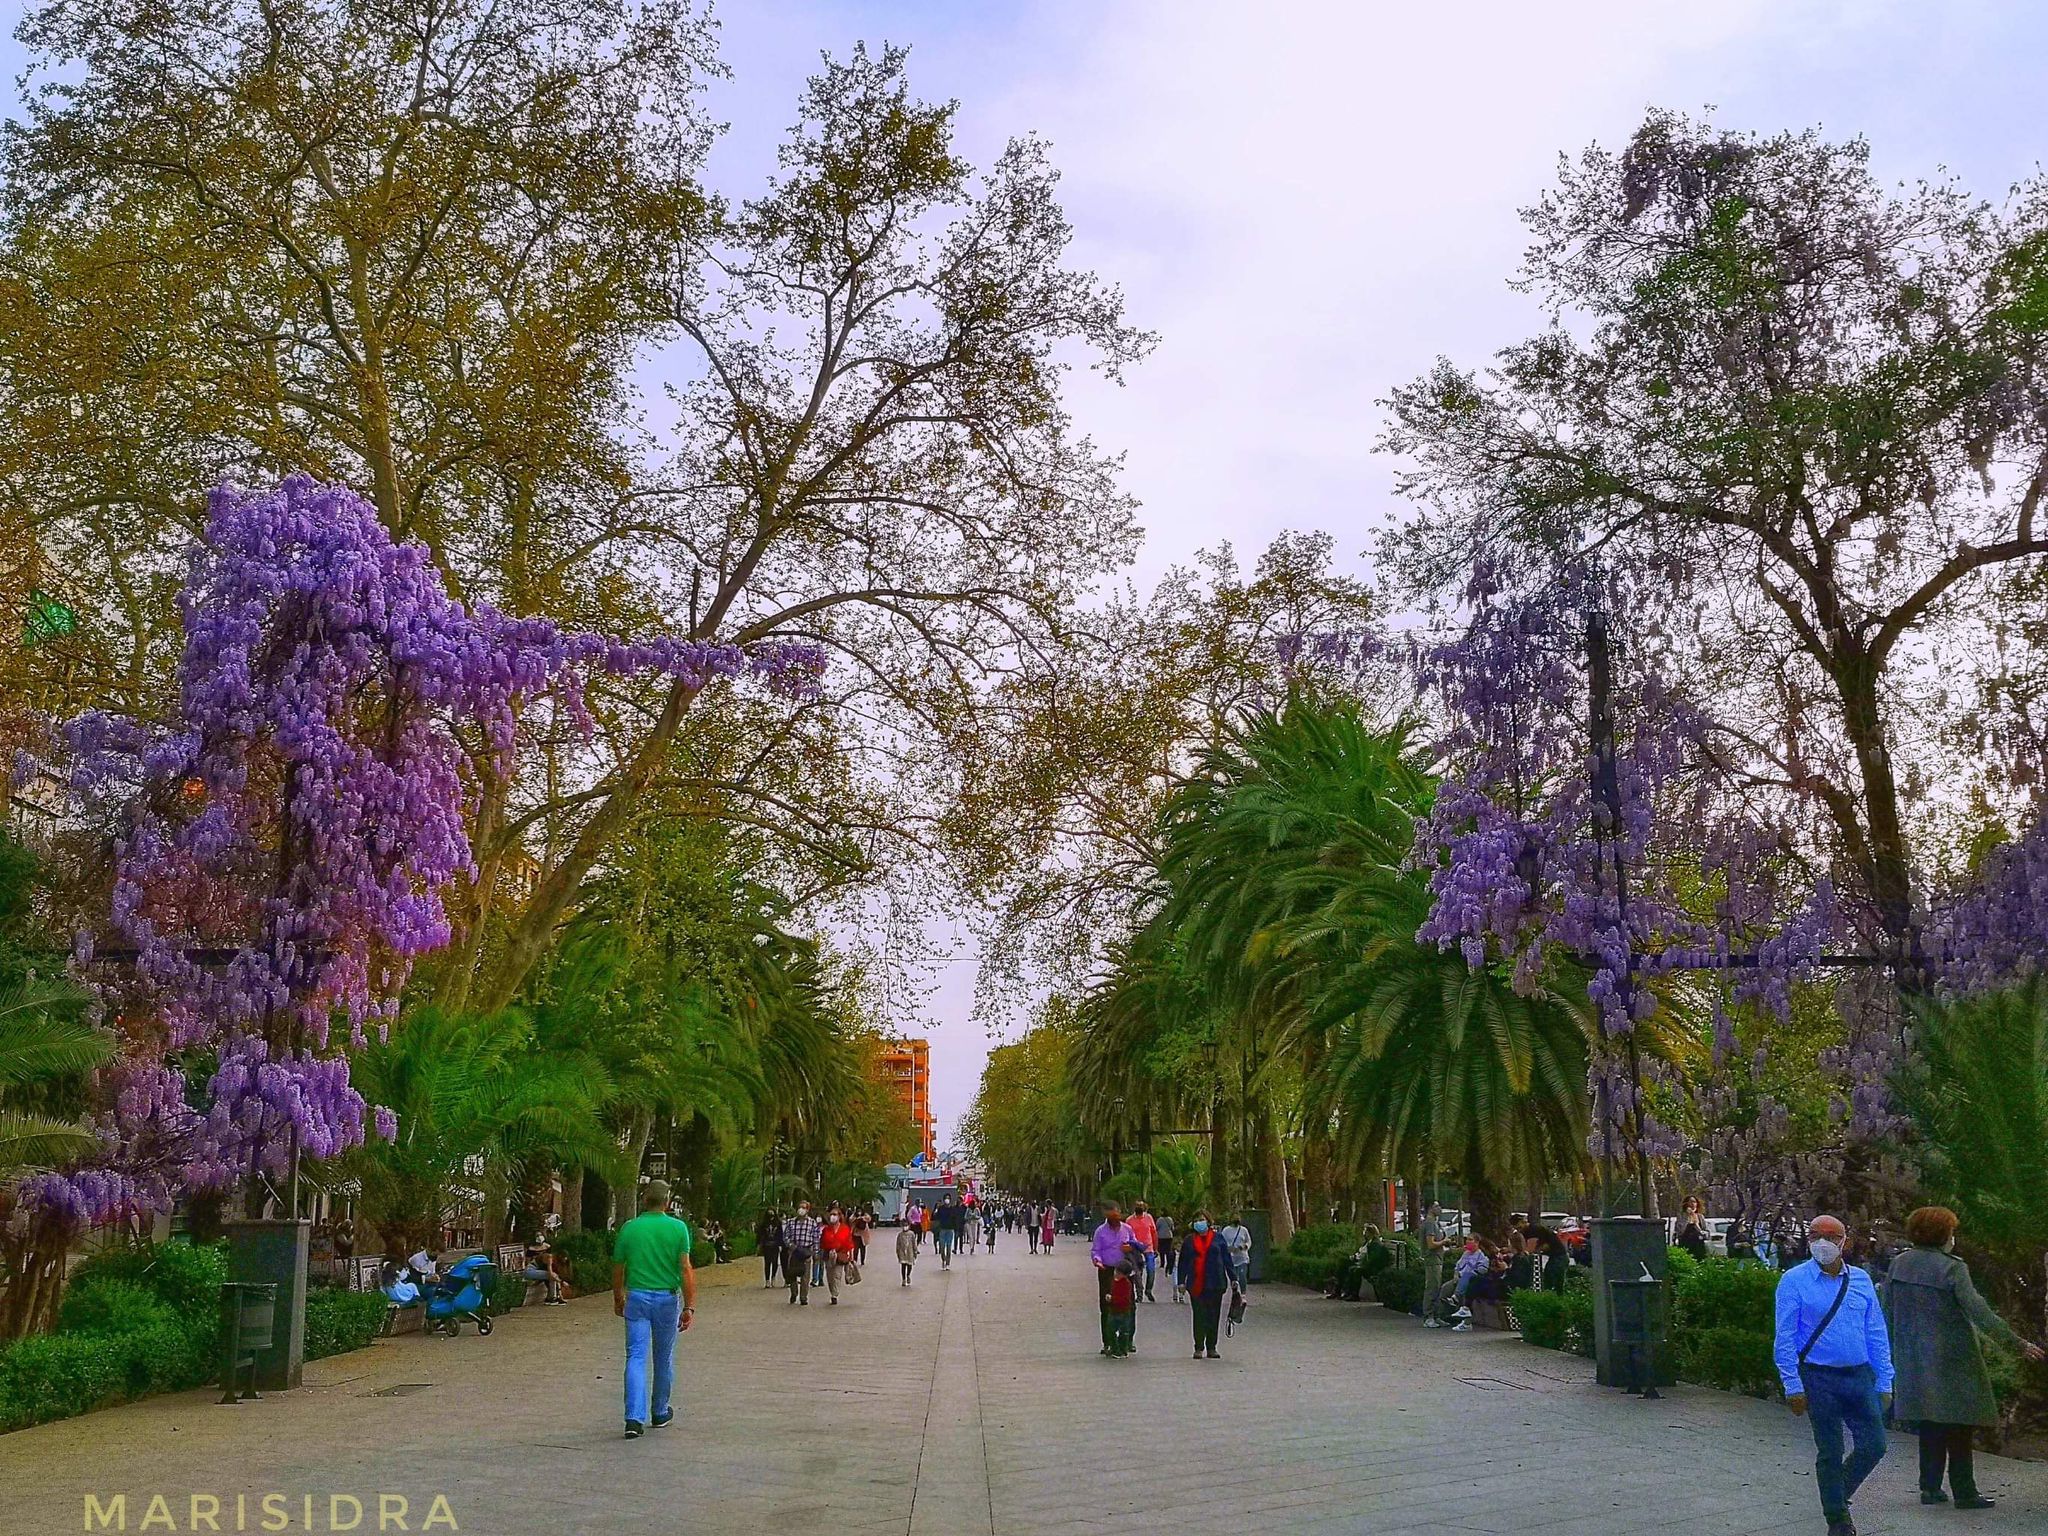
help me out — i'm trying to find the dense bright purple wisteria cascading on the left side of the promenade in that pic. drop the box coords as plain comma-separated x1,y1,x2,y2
41,475,823,1210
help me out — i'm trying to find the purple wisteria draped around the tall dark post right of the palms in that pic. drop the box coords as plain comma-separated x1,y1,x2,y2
1413,565,1839,1155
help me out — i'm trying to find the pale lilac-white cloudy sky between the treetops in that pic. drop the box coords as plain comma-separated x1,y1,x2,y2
0,0,2048,1147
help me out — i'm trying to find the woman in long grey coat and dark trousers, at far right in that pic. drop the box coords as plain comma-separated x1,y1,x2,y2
1884,1206,2042,1509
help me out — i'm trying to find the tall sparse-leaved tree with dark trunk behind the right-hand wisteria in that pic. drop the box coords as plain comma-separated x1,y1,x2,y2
1386,113,2048,979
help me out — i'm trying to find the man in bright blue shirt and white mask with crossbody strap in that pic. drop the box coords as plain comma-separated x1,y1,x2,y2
1774,1217,1892,1536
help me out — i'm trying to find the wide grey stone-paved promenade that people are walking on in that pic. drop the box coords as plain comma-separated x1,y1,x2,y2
0,1233,2048,1536
